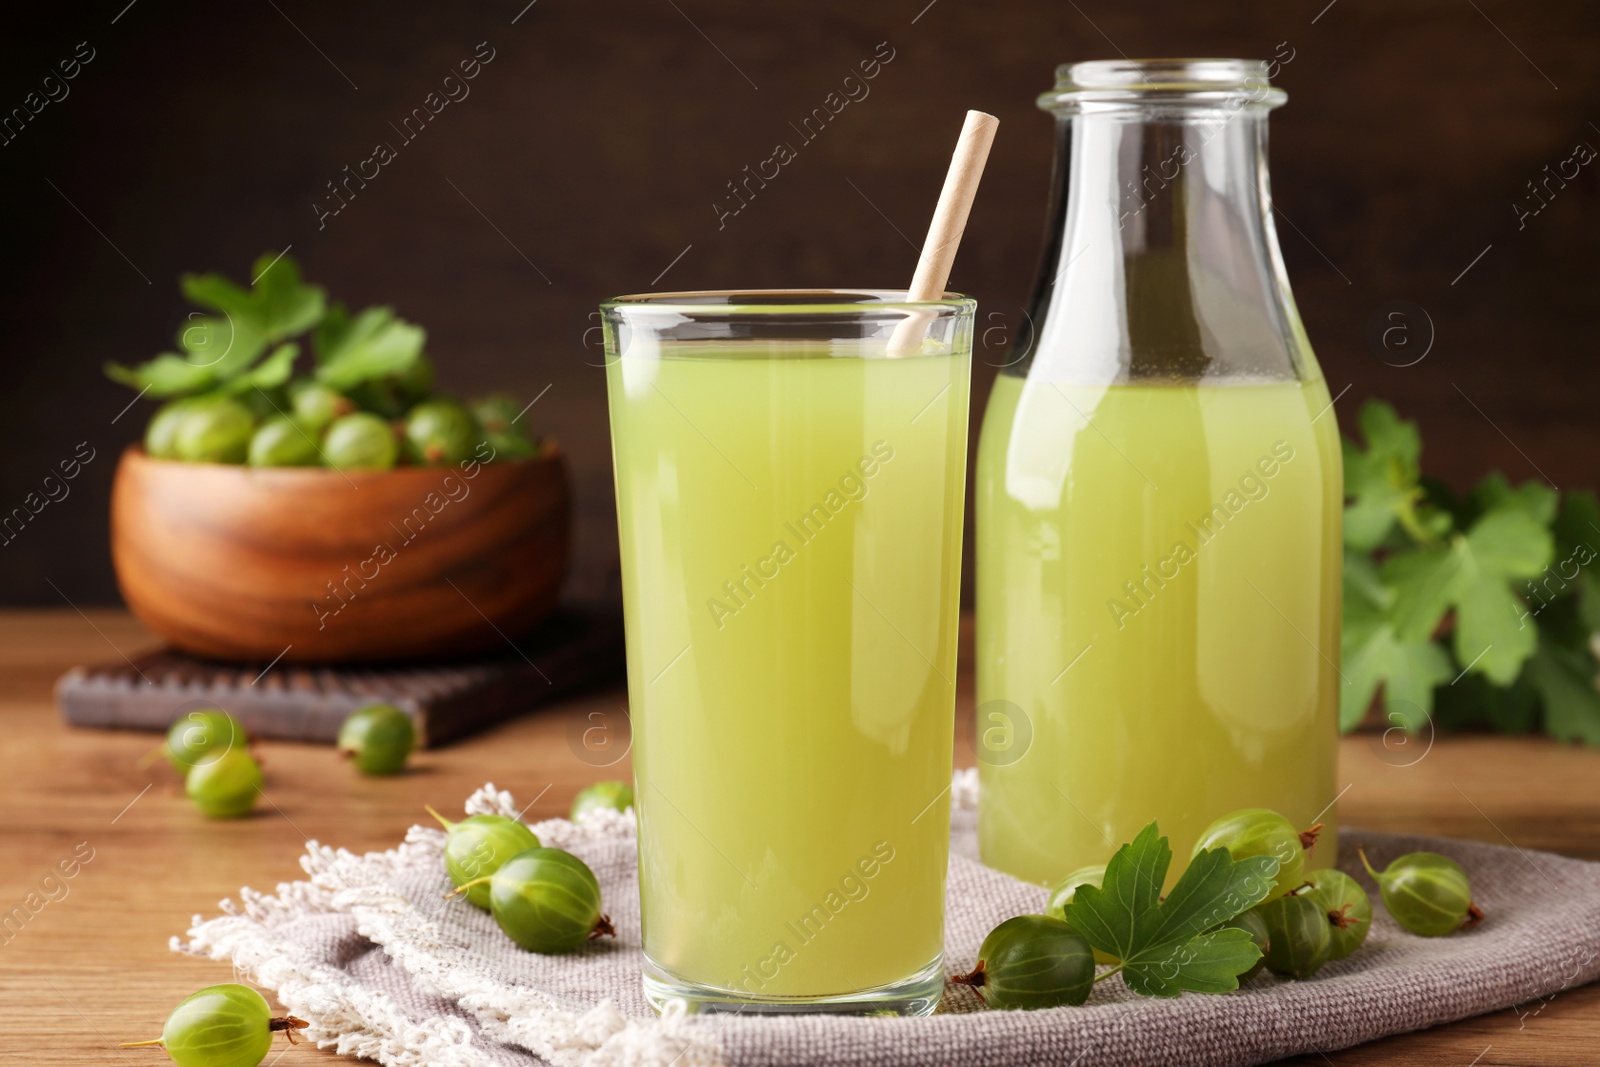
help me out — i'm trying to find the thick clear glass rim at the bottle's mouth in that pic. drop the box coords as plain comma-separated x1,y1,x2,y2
1038,59,1288,114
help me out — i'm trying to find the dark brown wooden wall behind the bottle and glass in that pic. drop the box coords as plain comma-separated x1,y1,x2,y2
0,0,1600,605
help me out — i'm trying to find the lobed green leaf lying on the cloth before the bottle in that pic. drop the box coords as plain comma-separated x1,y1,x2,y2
1066,822,1278,997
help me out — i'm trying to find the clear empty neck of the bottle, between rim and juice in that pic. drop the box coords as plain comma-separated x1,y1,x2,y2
1011,104,1315,384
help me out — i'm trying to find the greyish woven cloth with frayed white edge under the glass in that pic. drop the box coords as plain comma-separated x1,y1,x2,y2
173,773,1600,1067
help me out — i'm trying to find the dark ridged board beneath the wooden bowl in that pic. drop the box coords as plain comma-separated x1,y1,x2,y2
56,606,624,747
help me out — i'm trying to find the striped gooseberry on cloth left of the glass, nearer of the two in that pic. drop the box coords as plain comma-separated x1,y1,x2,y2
450,848,616,955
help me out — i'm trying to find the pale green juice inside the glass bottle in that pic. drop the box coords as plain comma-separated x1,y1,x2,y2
978,374,1342,883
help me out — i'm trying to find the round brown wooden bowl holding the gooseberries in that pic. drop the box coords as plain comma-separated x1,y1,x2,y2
110,443,571,664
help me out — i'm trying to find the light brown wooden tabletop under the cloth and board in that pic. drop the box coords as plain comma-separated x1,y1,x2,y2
0,609,1600,1067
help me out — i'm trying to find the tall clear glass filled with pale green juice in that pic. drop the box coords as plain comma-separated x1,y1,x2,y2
602,290,976,1014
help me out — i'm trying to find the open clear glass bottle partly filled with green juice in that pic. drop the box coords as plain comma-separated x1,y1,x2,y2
976,59,1342,886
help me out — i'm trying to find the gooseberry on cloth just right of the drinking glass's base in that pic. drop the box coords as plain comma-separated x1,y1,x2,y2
950,915,1094,1011
